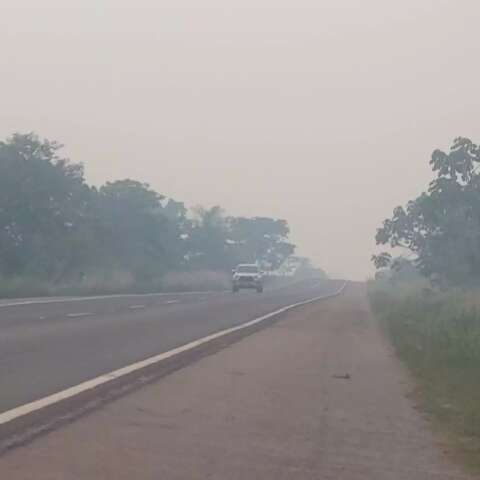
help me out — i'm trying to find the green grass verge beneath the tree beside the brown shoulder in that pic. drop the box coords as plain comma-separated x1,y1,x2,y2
369,282,480,472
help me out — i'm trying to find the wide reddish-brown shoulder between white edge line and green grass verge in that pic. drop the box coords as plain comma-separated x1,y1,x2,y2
0,285,472,480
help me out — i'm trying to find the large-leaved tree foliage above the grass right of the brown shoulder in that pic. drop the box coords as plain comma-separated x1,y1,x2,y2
372,137,480,285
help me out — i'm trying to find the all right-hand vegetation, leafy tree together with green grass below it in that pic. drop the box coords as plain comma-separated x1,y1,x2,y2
369,138,480,471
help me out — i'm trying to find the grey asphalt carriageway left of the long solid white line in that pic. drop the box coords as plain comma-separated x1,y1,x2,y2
0,280,339,412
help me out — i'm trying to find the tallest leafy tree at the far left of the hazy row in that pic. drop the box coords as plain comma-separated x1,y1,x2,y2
0,133,90,278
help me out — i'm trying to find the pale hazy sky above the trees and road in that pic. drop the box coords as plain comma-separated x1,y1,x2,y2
0,0,480,278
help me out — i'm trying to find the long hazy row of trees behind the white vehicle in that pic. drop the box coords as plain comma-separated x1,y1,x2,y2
0,133,295,284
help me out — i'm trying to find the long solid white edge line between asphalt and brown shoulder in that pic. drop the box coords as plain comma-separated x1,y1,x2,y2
0,282,347,425
